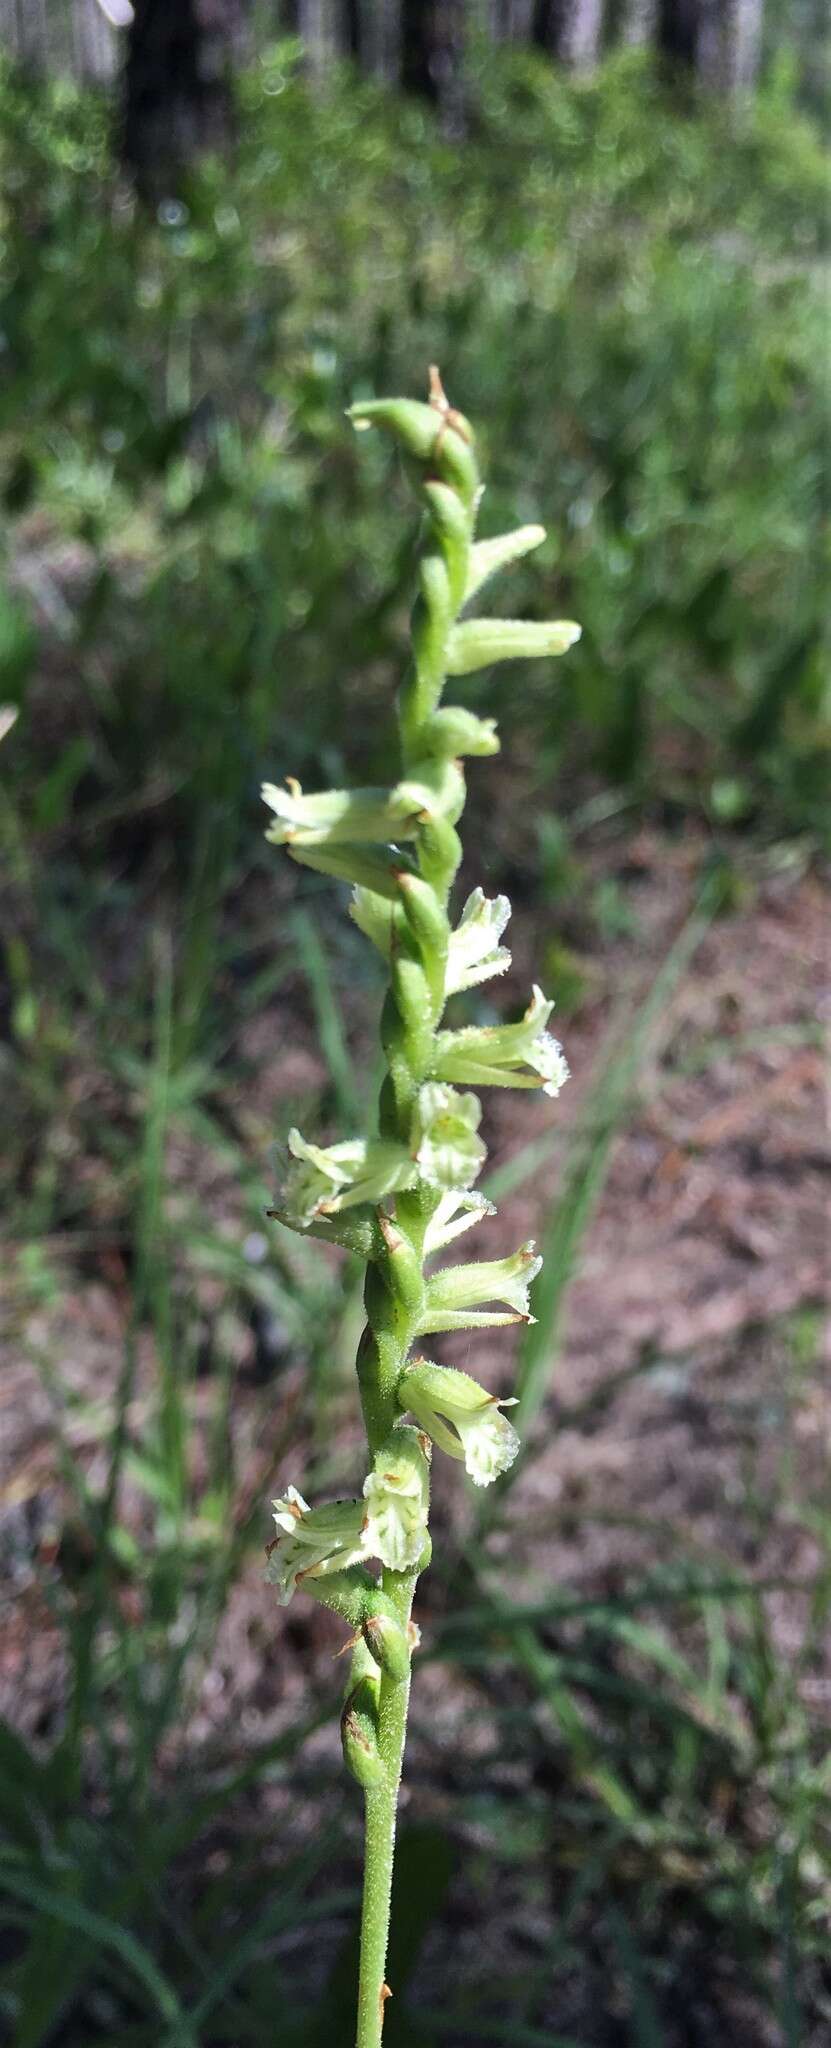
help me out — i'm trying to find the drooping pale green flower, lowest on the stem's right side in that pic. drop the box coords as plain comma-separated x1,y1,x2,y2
397,1358,520,1487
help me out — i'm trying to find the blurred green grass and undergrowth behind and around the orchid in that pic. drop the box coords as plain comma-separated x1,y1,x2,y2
0,16,831,2048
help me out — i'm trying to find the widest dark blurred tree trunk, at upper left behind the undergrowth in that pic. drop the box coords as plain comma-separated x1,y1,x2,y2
121,0,235,193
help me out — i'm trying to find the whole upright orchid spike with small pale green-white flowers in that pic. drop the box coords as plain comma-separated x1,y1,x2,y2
262,371,579,2048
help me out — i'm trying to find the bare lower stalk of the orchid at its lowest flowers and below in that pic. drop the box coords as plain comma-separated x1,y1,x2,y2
356,1571,418,2048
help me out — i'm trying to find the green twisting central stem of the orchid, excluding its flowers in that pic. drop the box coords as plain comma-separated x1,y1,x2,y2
356,373,477,2048
